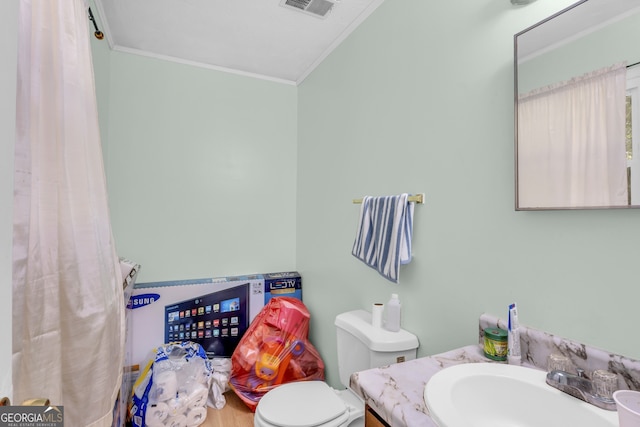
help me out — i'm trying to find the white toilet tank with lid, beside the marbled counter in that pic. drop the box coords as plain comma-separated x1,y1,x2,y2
335,310,419,387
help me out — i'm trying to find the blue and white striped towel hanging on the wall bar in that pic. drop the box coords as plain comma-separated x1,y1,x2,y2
351,194,414,283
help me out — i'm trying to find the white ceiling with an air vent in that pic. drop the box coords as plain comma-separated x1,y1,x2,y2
93,0,384,84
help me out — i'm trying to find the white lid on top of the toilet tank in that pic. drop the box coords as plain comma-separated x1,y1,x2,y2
335,310,419,352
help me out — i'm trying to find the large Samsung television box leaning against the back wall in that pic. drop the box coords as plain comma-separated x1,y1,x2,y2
126,272,302,366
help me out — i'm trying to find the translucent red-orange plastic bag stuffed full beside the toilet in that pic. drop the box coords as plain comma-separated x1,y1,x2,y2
229,297,324,412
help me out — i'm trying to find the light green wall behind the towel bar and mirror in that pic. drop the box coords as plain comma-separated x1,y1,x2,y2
297,0,640,385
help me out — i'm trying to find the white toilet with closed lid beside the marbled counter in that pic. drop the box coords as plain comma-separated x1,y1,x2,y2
253,310,418,427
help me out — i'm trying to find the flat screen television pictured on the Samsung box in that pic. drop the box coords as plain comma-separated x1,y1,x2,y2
164,283,249,358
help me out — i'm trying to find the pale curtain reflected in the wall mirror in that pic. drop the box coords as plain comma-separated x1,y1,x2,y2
518,64,628,208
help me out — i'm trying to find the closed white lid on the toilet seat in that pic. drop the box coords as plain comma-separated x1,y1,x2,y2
257,381,348,427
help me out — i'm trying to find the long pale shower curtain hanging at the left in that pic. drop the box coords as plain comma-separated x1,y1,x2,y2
13,0,124,427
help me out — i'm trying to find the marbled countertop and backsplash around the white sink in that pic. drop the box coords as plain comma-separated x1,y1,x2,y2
350,314,640,427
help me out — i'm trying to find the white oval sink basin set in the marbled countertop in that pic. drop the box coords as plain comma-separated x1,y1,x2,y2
424,363,618,427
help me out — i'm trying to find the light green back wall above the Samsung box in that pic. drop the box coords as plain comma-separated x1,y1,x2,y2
102,51,297,282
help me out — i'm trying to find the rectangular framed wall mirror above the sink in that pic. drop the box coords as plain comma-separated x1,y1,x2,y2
514,0,640,210
